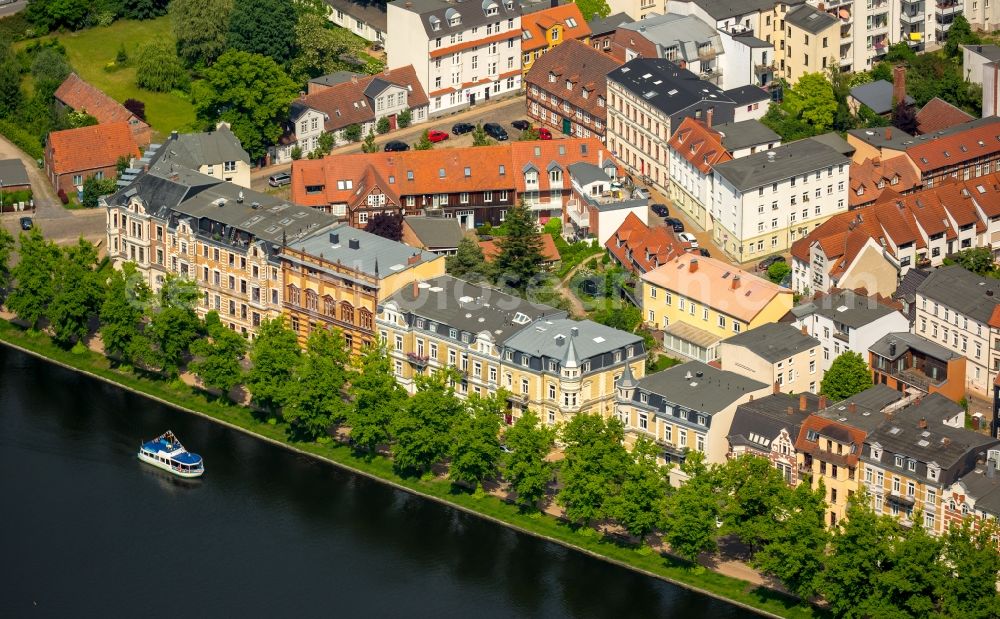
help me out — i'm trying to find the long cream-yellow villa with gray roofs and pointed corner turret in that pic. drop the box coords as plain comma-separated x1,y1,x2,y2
376,276,646,425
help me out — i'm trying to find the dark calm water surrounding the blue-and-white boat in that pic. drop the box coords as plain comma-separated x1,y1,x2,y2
0,346,755,619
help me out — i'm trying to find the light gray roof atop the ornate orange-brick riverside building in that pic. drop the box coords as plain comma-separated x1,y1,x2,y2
288,222,443,277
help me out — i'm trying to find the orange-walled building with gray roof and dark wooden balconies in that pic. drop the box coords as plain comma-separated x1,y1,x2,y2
868,331,965,402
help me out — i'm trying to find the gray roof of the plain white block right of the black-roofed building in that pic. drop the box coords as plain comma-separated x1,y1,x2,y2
713,138,850,191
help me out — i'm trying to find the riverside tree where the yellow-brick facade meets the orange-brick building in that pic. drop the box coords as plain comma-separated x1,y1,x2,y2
245,318,301,415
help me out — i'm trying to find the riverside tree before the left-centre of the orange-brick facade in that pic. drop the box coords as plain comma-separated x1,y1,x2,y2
282,329,350,441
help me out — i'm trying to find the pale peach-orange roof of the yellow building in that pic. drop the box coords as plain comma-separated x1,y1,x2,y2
642,253,792,322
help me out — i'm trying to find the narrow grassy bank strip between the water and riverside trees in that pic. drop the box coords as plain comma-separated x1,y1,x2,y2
0,318,822,618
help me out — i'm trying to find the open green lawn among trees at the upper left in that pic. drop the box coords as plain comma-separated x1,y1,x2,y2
19,16,195,138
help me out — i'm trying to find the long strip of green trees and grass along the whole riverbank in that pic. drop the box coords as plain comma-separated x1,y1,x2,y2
0,224,1000,618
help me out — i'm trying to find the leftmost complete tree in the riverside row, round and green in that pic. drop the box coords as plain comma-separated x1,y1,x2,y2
7,227,60,329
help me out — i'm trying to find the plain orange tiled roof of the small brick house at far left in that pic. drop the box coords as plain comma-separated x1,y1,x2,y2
48,122,142,174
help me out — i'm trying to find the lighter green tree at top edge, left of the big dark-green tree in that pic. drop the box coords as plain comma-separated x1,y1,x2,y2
170,0,234,68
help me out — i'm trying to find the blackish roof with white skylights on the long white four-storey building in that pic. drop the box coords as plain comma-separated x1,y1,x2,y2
608,58,735,116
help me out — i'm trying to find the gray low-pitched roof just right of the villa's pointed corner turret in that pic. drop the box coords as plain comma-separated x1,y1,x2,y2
639,361,767,414
